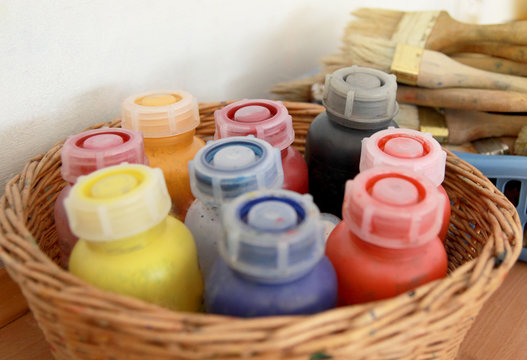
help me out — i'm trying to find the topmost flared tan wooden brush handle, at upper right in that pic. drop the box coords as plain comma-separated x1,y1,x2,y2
426,11,527,50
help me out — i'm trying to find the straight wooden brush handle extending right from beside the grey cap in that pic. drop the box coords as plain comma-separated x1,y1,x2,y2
397,85,527,112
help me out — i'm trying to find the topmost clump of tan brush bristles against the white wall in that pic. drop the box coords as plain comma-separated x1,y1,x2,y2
343,8,405,42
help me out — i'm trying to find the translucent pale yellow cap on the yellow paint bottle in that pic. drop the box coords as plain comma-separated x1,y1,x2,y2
64,164,171,241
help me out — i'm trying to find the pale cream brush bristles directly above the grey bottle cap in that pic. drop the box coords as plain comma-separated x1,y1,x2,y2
342,35,396,72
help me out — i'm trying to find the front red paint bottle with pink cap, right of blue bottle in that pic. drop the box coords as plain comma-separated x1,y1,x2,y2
326,167,447,305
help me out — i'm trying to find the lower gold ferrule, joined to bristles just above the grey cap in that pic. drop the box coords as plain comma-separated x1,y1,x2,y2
390,43,424,85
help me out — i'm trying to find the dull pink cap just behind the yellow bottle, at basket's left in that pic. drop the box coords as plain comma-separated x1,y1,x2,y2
61,128,148,184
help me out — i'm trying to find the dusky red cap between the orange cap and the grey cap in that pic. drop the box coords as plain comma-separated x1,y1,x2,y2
214,99,295,150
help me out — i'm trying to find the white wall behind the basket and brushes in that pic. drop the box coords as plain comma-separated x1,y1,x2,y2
0,0,506,194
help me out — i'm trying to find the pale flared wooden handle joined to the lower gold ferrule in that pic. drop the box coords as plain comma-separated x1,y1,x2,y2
417,50,527,93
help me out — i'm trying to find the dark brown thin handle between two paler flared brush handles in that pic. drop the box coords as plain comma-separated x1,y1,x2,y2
441,41,527,63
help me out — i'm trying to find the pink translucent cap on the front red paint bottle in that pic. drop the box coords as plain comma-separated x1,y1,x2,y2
342,167,444,248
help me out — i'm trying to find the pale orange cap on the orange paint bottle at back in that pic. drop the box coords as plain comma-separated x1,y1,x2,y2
121,90,199,138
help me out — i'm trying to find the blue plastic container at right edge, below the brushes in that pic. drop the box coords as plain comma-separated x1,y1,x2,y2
455,152,527,262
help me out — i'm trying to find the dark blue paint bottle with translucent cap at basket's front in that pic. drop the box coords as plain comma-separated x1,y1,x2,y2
205,190,337,317
